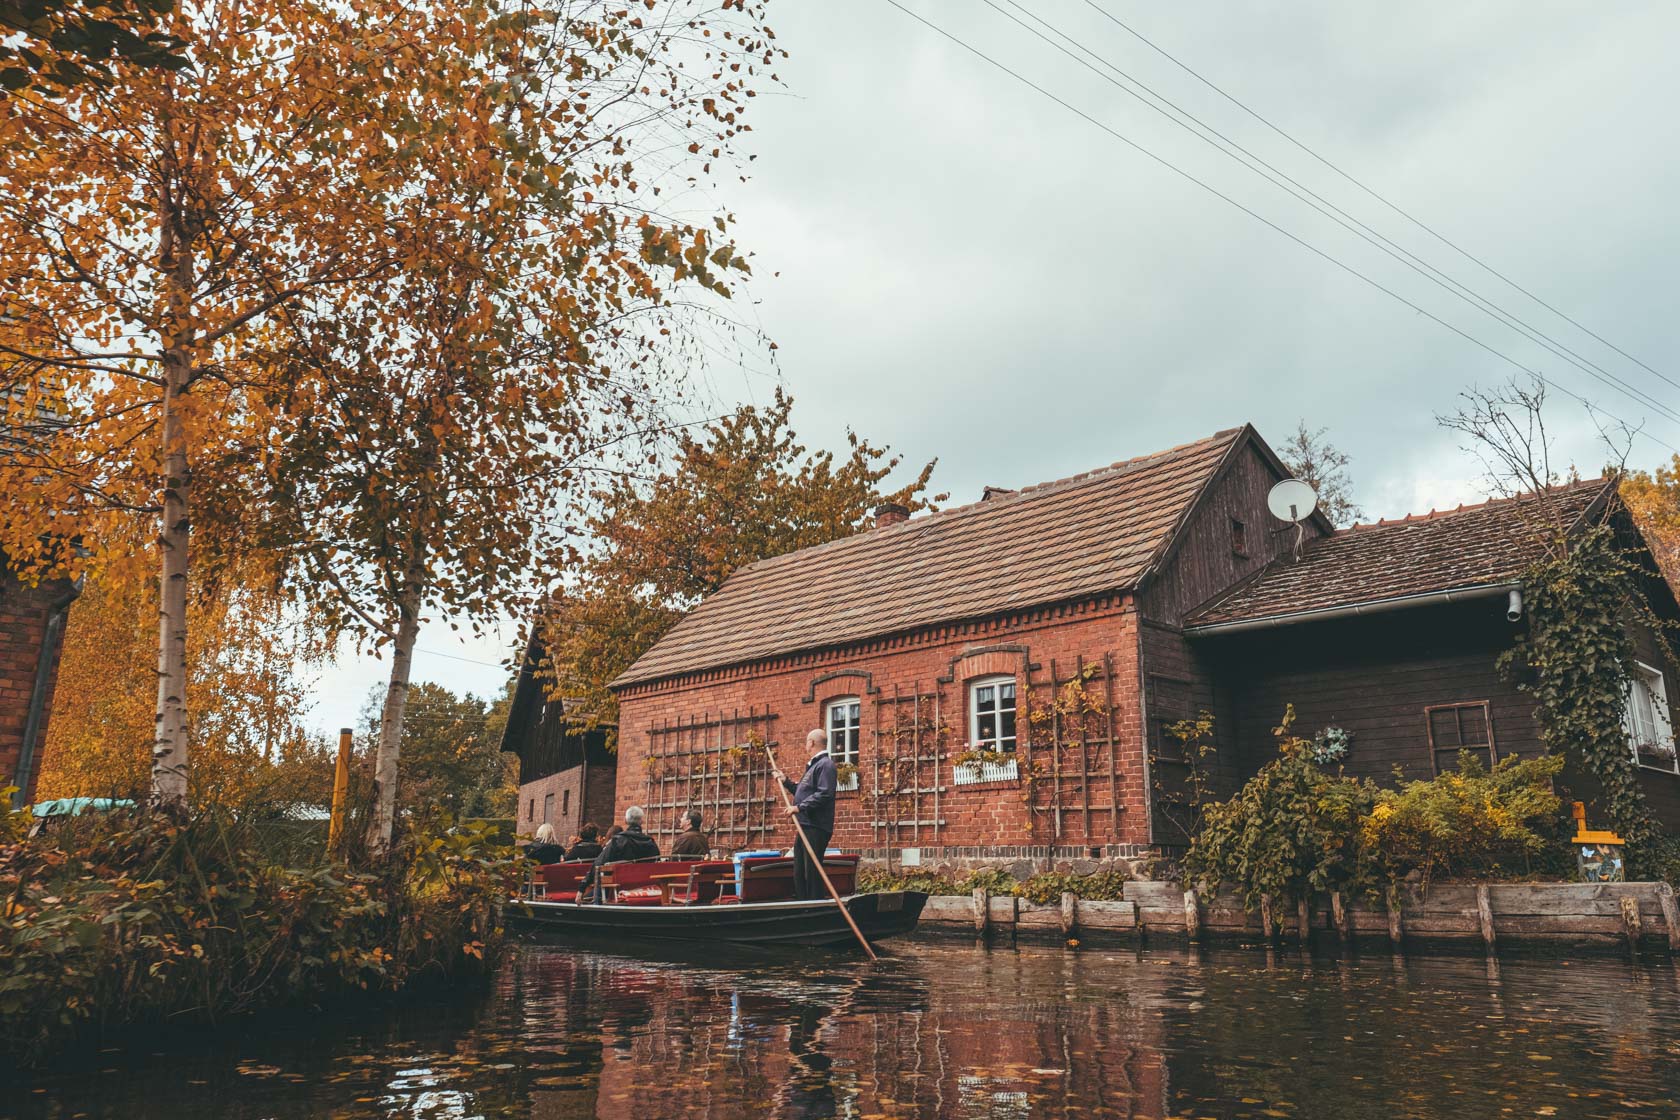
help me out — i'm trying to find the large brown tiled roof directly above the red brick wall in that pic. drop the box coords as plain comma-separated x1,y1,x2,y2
613,428,1248,685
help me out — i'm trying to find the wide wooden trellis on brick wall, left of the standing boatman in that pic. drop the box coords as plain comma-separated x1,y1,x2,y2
642,707,776,848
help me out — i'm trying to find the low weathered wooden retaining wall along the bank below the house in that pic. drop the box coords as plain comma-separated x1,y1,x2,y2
922,882,1680,952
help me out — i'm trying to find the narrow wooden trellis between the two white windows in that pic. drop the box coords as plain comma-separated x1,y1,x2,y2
870,682,951,845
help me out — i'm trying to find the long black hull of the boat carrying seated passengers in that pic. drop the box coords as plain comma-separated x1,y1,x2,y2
506,890,927,945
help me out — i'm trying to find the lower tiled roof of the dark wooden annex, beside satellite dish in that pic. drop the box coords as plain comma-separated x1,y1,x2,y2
1184,479,1614,628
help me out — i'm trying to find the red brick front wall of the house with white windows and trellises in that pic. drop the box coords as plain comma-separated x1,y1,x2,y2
617,596,1149,863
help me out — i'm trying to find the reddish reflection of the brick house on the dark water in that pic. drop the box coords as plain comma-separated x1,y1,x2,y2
514,954,1169,1120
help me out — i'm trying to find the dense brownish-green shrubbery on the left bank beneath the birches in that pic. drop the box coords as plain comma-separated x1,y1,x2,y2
0,809,519,1060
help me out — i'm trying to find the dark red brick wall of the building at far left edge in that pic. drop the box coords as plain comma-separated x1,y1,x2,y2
0,556,81,804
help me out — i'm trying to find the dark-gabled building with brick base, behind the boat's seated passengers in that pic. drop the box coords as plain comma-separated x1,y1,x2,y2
502,641,618,841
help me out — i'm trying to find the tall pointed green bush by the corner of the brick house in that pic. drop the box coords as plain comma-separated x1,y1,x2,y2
1184,707,1378,908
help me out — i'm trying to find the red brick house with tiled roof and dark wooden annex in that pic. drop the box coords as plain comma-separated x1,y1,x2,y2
613,427,1680,863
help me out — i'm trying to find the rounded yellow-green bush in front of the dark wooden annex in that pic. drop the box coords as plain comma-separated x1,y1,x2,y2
1359,751,1564,887
